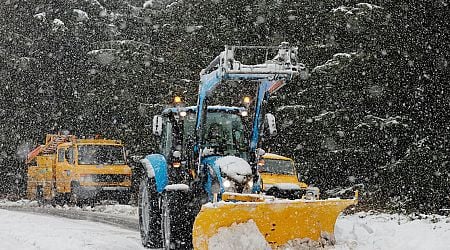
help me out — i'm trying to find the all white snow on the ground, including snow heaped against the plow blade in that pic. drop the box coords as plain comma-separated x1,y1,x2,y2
0,200,450,250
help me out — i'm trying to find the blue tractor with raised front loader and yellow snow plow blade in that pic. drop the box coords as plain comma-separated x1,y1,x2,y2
138,43,357,249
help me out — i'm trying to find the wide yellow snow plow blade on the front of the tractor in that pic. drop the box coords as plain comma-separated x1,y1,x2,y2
193,193,358,250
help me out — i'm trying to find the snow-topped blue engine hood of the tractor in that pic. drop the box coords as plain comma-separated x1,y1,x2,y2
203,156,252,183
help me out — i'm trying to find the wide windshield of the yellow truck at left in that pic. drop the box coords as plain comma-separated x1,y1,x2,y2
78,145,125,165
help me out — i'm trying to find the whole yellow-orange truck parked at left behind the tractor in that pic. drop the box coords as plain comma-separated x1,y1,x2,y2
26,134,131,205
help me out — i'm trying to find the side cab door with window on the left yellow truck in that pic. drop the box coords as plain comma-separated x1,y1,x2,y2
55,147,76,193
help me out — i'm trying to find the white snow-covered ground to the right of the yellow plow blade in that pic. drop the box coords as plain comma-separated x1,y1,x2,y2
335,213,450,250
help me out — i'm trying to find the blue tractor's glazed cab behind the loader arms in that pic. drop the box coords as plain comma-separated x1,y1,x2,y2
153,106,249,159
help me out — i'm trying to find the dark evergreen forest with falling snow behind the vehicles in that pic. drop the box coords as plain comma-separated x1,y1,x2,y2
0,0,450,212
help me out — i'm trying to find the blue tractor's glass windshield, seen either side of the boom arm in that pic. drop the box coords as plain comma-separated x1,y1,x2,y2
184,112,247,158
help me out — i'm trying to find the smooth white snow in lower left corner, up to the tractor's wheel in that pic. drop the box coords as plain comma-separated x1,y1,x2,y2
0,209,145,250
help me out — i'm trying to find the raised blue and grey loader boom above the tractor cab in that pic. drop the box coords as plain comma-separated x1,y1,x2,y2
195,43,304,162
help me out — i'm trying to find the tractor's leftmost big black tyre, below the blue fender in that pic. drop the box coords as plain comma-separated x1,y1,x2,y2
138,176,163,248
